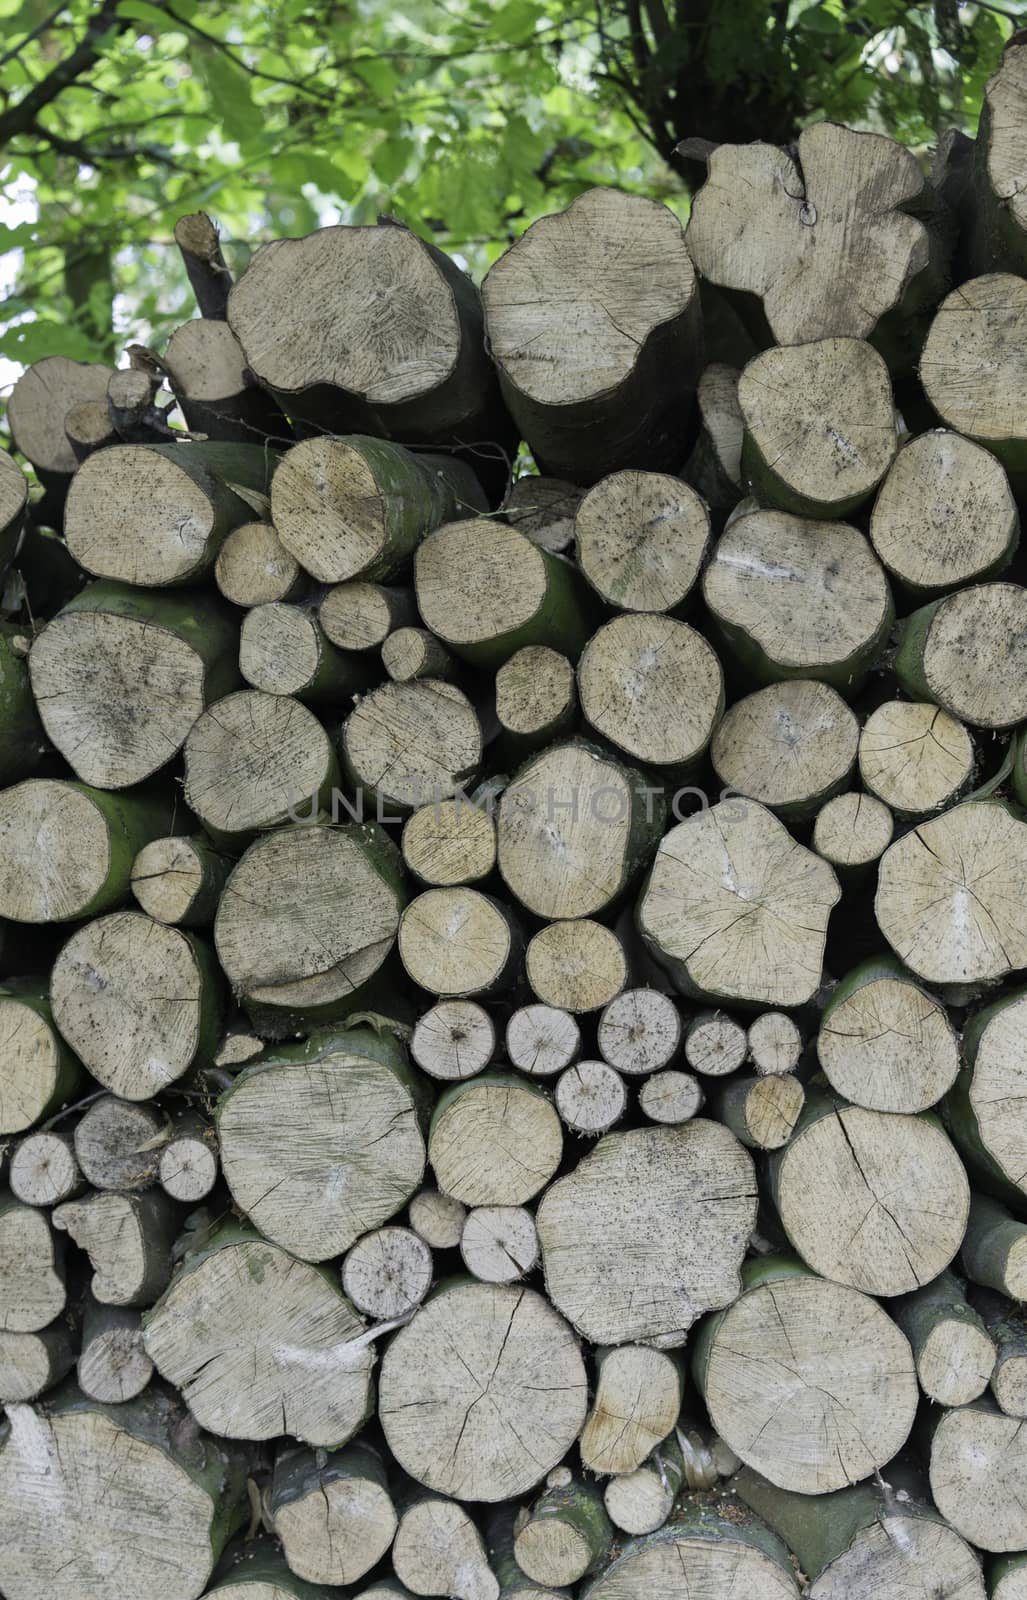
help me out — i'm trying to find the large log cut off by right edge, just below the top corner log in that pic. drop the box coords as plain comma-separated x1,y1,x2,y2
920,272,1027,477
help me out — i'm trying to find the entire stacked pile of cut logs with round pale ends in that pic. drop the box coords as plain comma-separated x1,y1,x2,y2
0,42,1027,1600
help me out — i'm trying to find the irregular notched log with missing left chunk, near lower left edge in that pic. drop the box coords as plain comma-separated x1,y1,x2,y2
53,1189,178,1306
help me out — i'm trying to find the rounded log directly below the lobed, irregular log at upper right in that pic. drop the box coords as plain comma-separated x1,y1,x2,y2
737,334,897,517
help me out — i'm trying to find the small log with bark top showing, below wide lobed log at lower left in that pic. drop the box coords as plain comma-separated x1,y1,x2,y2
270,1443,397,1584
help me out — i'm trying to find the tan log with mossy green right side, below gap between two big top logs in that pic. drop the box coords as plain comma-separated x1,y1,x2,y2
414,517,593,667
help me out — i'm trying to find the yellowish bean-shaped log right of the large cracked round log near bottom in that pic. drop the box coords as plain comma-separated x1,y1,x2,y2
579,1344,685,1475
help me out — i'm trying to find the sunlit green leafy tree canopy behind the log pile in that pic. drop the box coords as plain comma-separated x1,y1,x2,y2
0,0,1027,363
